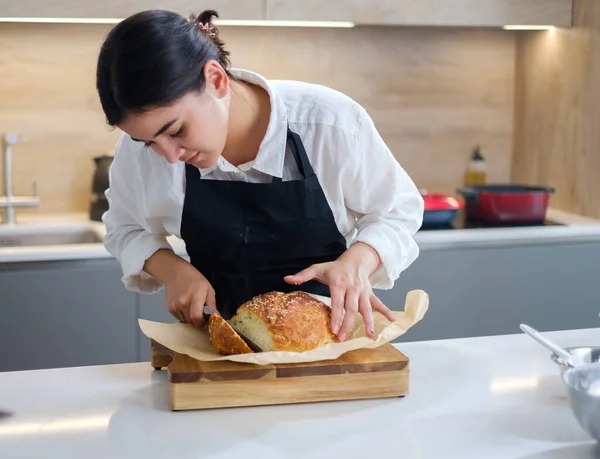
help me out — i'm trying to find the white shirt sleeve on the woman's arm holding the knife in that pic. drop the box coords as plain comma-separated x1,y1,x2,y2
102,135,172,293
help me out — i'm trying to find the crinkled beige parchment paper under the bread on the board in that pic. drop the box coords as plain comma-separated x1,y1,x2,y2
138,290,429,365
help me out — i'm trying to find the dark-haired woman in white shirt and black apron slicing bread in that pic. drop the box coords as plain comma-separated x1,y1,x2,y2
97,10,423,341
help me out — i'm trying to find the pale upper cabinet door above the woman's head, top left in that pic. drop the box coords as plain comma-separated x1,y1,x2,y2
0,0,262,19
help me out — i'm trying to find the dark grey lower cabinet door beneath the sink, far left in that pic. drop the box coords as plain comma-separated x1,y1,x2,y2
0,260,137,371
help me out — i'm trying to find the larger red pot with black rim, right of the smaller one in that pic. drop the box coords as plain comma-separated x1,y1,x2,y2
458,185,555,223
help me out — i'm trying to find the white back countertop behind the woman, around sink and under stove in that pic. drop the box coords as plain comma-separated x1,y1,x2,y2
0,209,600,263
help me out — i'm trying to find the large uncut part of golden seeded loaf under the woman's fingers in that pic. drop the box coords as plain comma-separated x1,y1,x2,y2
229,292,338,352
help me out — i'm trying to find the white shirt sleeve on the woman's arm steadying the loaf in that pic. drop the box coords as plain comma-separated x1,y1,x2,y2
343,109,424,289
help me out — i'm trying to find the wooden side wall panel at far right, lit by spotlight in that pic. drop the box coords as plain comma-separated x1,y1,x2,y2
511,0,600,217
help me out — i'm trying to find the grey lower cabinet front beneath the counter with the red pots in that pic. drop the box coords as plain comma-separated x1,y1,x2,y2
376,242,600,341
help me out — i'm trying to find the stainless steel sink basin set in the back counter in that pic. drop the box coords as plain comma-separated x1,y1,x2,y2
0,226,102,248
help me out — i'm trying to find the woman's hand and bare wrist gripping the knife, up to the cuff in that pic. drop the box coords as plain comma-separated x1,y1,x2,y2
144,249,217,326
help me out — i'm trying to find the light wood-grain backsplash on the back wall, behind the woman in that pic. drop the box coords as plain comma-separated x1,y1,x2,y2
0,24,515,213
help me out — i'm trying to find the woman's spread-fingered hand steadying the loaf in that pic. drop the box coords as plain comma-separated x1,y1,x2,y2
285,242,396,341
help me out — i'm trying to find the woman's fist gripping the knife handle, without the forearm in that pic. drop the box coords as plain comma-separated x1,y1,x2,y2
165,264,217,326
